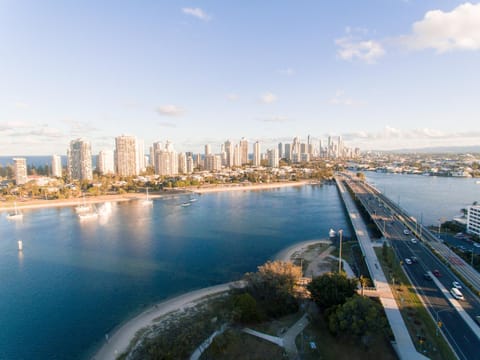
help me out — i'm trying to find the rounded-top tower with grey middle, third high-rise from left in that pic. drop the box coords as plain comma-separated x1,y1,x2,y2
67,139,93,180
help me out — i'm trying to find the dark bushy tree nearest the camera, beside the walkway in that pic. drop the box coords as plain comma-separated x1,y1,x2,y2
328,295,387,343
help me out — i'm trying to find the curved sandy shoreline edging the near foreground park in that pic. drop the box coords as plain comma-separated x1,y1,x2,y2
92,239,327,360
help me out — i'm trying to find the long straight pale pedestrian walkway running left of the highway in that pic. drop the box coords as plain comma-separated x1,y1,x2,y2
335,177,427,360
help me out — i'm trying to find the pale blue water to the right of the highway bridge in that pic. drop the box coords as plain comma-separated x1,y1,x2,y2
365,171,480,225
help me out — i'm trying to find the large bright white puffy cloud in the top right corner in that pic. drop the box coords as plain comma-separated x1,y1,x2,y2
400,2,480,53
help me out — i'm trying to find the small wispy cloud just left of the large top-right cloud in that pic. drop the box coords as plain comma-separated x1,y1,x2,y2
335,33,385,64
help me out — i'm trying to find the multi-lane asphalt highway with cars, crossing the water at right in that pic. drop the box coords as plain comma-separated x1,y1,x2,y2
343,176,480,359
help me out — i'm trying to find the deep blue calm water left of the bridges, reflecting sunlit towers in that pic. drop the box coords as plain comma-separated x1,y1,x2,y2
0,185,349,359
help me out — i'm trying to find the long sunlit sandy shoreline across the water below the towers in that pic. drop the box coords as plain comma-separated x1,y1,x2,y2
0,181,308,212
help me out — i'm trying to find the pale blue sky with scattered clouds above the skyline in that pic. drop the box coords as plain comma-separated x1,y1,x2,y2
0,0,480,156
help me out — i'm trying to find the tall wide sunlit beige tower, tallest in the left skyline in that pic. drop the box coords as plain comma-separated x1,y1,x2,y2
115,135,138,176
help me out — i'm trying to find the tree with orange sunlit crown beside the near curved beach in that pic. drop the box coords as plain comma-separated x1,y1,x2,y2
245,261,302,317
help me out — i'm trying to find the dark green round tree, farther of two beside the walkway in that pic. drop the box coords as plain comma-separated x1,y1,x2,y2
307,273,357,310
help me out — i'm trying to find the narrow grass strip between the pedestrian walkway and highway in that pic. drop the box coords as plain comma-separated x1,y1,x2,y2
375,247,456,360
